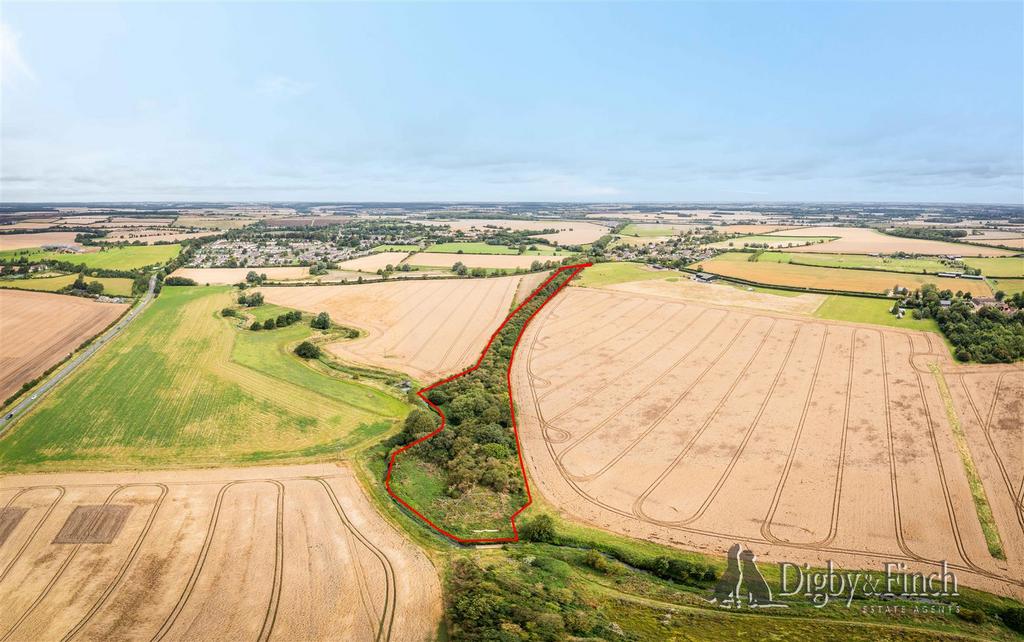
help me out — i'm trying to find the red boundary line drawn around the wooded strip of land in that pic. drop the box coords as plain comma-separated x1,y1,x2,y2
384,263,592,544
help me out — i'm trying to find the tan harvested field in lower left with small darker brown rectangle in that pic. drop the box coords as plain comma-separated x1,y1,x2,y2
0,465,441,640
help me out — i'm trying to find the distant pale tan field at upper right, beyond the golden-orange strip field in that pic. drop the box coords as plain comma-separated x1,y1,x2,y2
772,227,1013,256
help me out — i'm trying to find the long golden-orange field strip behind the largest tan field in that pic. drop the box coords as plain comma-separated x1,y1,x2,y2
700,254,992,297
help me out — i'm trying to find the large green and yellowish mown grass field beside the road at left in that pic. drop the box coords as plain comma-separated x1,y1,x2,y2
0,287,408,471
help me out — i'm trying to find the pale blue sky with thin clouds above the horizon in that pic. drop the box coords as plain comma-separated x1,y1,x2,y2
0,1,1024,205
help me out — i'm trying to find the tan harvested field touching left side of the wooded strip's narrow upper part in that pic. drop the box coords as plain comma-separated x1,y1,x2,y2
260,276,522,381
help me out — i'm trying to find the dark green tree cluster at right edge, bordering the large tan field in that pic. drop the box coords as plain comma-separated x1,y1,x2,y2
894,284,1024,363
